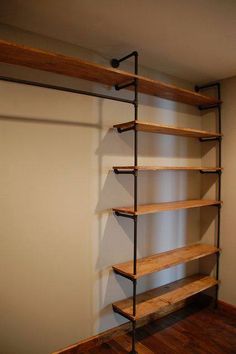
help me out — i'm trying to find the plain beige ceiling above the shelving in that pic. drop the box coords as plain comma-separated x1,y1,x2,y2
0,0,236,82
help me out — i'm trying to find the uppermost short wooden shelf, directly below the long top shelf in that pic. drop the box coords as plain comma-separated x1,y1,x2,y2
113,120,222,138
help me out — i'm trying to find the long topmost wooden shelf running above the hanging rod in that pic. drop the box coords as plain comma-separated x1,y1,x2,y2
0,40,221,106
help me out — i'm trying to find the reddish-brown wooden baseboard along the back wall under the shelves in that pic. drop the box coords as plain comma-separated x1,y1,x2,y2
52,297,194,354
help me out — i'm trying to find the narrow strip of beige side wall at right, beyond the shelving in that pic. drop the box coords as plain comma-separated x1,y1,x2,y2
220,77,236,305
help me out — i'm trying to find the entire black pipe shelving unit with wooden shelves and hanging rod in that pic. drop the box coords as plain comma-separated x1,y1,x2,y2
0,40,222,354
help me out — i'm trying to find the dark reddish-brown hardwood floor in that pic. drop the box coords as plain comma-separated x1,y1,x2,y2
83,305,236,354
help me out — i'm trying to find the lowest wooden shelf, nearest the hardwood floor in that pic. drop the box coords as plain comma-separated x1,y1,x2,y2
113,274,218,321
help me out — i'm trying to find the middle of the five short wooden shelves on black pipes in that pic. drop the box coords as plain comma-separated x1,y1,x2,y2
113,199,222,215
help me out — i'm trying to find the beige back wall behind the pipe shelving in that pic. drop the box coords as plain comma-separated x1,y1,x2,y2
0,26,218,354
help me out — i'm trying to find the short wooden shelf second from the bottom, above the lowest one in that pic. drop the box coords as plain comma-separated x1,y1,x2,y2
112,244,219,279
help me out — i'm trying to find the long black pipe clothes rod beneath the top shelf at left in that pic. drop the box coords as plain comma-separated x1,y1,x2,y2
0,76,134,104
